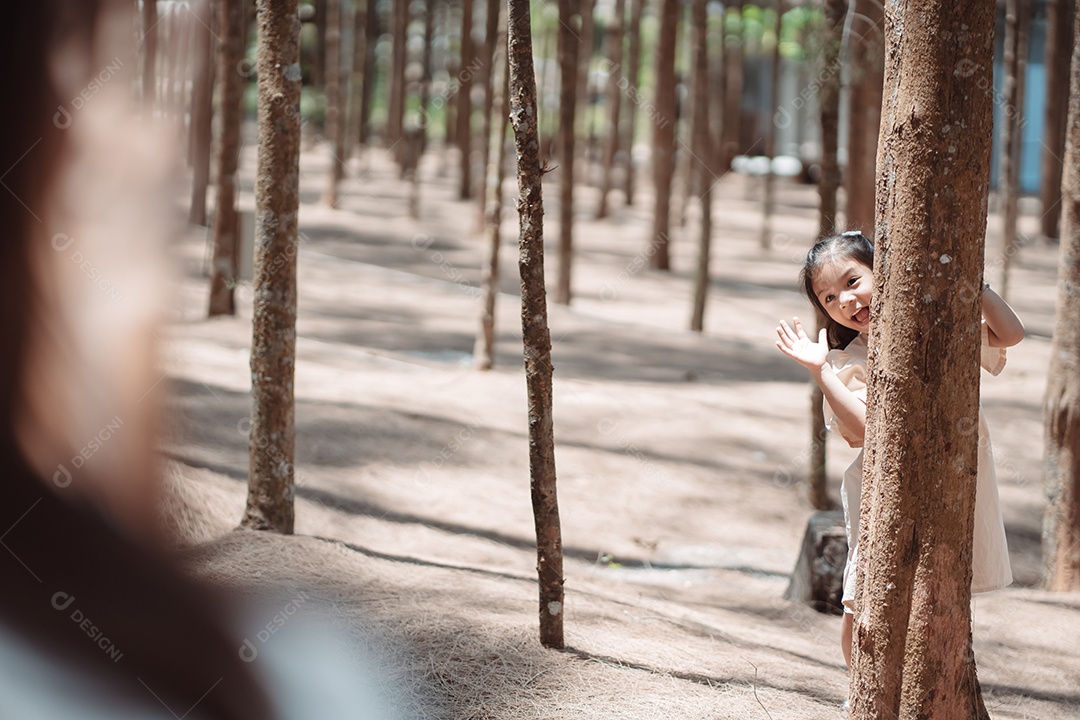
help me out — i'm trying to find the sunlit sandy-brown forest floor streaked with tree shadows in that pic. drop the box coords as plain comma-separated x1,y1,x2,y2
164,138,1080,720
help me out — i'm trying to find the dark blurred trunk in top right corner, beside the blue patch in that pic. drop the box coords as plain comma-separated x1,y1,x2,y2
1040,0,1076,237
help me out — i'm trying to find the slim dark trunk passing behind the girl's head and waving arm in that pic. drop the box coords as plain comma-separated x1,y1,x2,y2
807,0,848,510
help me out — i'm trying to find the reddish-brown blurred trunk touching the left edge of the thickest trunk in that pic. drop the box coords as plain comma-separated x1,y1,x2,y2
843,0,885,237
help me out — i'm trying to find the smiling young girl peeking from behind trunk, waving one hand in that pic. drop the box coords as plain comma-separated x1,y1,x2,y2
777,232,1024,666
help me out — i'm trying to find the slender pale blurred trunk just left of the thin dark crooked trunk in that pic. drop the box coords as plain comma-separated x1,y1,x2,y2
473,2,510,370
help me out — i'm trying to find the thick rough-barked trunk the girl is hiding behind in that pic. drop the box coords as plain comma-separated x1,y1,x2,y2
850,0,995,720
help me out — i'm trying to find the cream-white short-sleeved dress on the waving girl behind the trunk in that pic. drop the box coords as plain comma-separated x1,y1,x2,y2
824,322,1012,612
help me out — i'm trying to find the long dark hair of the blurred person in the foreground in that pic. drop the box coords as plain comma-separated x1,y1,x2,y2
0,0,276,720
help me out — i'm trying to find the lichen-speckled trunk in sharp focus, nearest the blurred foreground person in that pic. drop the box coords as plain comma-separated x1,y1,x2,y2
241,0,300,533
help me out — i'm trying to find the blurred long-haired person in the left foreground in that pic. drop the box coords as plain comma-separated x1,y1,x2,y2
0,0,395,720
